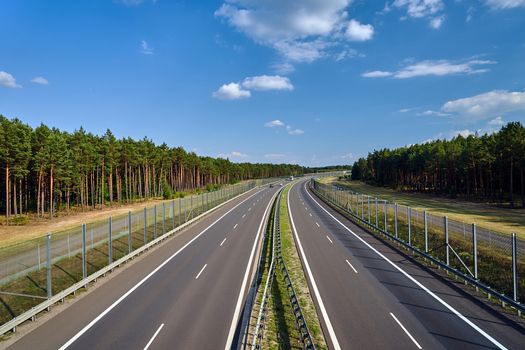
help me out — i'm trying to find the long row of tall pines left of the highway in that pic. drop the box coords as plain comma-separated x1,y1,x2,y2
0,115,304,223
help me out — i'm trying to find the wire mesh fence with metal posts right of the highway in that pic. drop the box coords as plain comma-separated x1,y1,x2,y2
312,180,525,303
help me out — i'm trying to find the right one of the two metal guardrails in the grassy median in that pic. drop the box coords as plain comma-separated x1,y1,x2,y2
274,192,315,349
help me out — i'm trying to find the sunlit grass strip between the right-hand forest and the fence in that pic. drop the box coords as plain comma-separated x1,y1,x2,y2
328,177,525,239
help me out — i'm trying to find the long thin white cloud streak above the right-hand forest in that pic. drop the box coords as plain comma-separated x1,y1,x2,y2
362,60,496,79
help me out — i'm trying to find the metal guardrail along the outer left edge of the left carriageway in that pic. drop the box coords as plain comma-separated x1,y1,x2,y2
0,185,270,336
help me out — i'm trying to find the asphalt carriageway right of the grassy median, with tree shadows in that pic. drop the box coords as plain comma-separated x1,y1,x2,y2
288,181,525,349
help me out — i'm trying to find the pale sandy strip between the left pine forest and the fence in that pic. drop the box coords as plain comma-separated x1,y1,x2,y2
0,200,162,246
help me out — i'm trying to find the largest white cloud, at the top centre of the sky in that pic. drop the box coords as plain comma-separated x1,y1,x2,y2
215,0,373,63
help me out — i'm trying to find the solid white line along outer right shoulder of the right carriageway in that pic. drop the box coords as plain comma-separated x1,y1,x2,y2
304,182,507,349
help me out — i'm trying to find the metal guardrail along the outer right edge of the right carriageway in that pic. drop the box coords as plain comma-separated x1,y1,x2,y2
309,179,525,314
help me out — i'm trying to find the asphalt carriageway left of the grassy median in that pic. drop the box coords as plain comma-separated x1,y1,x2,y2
7,187,277,349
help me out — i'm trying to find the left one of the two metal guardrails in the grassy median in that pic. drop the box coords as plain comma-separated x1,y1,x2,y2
251,189,283,350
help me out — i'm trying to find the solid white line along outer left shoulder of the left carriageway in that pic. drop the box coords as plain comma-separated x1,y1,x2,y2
58,189,263,350
